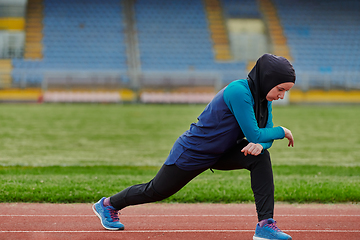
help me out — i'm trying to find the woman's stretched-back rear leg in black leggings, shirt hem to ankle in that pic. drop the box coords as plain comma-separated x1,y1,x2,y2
110,165,206,210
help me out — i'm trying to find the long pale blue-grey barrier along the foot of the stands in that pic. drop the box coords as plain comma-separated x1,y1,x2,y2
5,69,360,91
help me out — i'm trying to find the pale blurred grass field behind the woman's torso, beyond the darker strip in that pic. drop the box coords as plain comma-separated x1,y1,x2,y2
0,104,360,166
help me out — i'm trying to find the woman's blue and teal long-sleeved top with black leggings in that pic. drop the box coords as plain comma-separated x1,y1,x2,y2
110,79,285,221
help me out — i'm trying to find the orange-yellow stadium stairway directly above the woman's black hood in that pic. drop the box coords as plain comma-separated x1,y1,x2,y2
259,0,292,60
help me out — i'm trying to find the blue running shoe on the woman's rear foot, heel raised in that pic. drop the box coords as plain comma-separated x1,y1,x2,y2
93,197,125,230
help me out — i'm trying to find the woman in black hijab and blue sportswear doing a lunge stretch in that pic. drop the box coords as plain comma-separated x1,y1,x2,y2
93,54,295,239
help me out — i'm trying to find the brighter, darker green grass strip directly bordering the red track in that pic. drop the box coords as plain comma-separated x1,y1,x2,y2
0,165,360,203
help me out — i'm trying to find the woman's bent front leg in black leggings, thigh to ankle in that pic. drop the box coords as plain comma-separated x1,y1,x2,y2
211,141,274,221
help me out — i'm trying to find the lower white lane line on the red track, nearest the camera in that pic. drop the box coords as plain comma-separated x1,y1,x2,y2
0,229,360,234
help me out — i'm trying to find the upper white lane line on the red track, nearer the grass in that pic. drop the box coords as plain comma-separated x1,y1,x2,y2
0,214,360,218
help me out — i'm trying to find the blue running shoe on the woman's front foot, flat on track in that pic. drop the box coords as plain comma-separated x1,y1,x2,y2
253,218,292,240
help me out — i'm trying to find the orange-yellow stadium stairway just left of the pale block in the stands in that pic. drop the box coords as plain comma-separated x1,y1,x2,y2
204,0,232,61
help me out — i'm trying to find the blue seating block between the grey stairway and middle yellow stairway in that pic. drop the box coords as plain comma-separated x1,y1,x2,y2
135,0,245,82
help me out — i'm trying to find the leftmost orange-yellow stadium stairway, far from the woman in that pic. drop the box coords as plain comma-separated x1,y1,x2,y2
24,0,43,59
